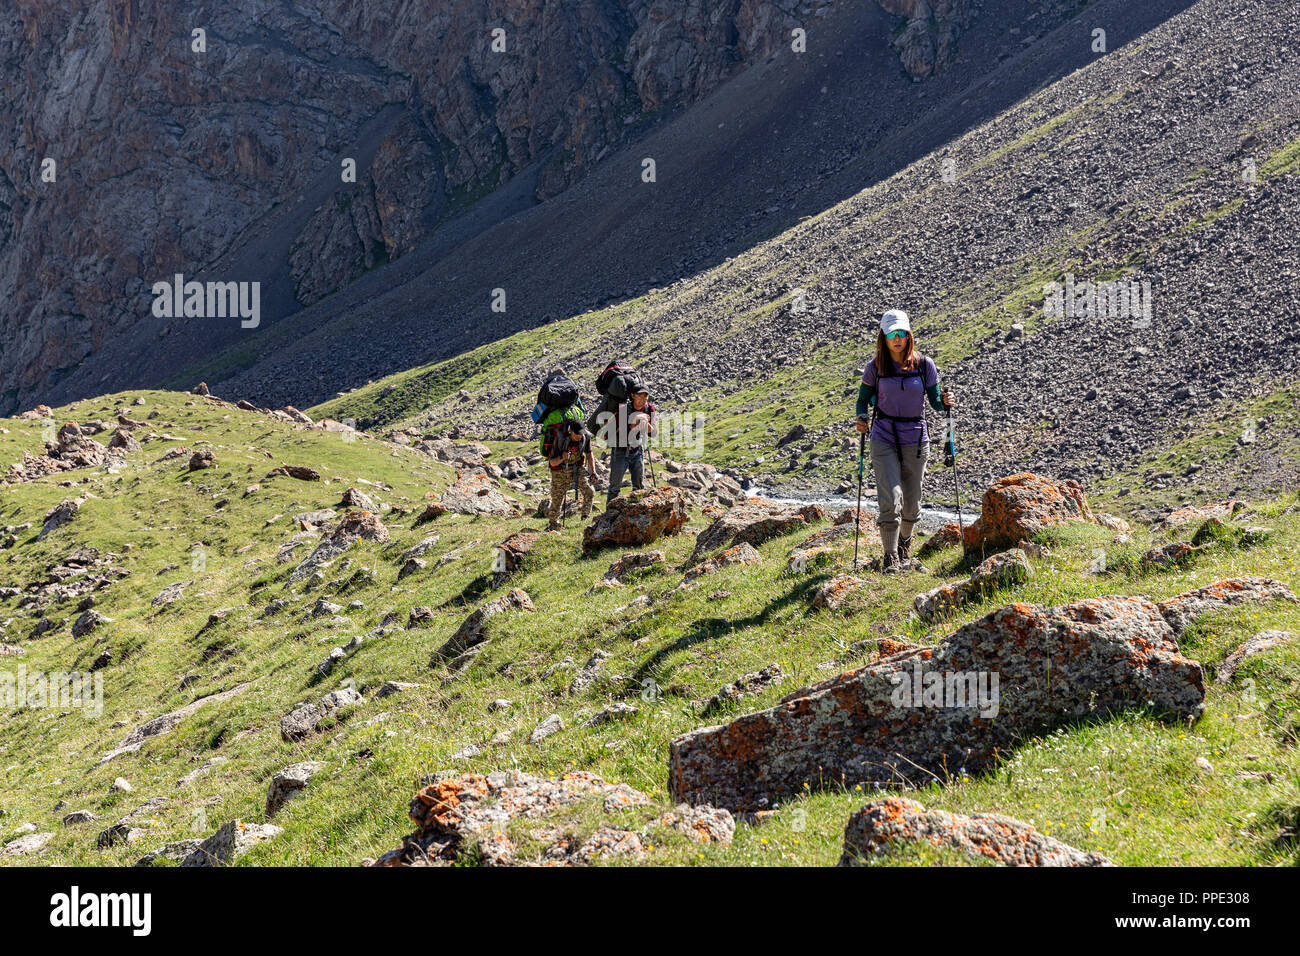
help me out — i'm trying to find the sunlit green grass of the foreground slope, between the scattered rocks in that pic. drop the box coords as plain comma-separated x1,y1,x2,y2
0,392,1300,865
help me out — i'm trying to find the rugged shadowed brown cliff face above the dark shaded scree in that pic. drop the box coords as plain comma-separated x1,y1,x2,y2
0,0,970,411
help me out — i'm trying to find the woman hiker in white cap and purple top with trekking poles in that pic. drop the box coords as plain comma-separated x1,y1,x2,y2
857,310,956,572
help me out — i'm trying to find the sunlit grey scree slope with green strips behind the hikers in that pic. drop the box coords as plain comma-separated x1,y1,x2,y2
314,0,1300,505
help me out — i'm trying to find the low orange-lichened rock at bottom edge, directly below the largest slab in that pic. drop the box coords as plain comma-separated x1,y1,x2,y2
840,796,1114,866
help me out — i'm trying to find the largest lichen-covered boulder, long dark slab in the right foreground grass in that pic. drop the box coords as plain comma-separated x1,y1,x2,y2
668,597,1205,810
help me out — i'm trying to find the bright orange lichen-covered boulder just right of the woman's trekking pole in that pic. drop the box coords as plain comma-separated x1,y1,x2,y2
962,472,1093,551
